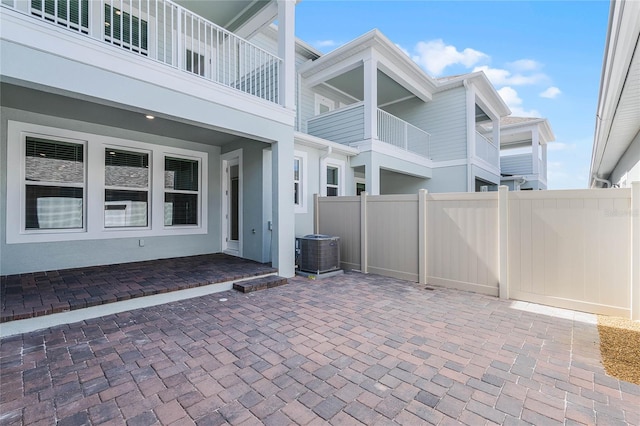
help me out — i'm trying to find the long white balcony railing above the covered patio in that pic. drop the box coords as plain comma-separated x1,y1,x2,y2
2,0,282,103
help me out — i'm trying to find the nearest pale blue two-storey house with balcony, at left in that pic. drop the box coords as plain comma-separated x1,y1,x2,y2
0,0,296,276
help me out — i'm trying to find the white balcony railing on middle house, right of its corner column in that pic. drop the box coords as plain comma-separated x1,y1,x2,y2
378,109,431,158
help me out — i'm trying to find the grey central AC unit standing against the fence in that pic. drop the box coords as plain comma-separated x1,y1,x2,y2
298,234,340,274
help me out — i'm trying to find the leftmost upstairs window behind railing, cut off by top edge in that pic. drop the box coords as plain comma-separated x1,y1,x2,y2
31,0,89,34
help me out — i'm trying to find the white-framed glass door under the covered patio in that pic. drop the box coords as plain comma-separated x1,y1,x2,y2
222,152,242,256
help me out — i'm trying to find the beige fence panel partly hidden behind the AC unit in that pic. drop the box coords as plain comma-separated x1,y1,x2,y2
318,197,360,269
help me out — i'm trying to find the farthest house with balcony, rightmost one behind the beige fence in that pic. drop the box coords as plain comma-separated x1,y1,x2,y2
500,117,555,191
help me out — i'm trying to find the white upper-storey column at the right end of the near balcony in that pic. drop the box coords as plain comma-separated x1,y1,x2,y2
278,0,296,110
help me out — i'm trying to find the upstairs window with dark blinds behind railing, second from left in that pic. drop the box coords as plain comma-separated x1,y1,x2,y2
104,4,149,55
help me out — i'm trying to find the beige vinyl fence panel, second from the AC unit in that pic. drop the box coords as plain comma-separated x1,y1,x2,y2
367,195,418,281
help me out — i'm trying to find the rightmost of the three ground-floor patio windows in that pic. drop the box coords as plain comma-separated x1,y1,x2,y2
164,157,200,226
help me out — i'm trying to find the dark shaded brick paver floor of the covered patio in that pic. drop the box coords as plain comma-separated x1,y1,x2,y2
0,253,277,322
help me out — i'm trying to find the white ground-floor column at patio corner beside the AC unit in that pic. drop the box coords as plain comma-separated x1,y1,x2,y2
271,129,295,278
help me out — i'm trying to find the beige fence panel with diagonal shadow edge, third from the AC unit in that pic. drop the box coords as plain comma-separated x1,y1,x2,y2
427,193,499,295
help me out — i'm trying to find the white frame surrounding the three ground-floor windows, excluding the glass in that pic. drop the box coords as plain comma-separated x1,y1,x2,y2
4,120,209,244
